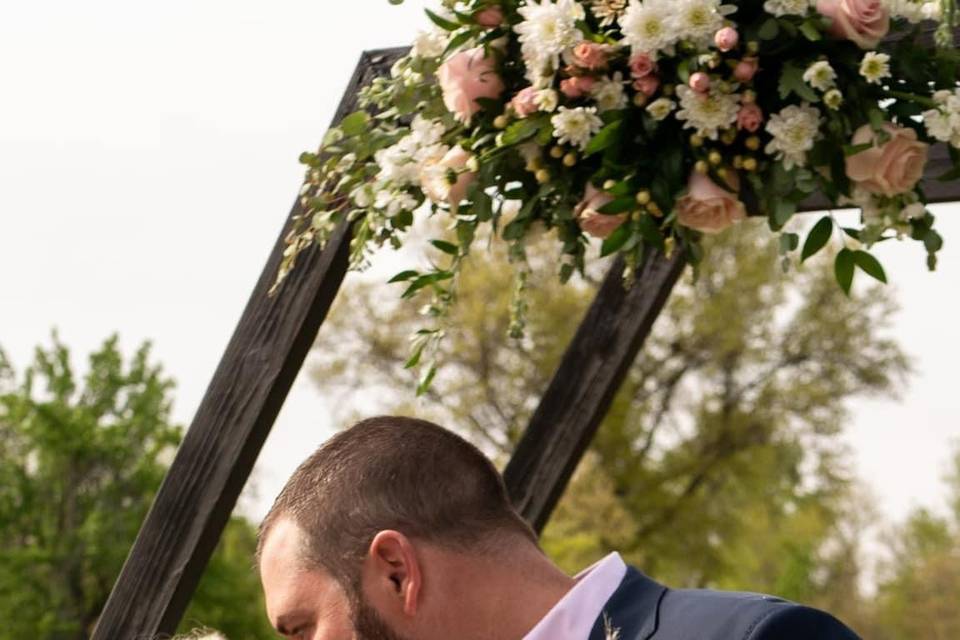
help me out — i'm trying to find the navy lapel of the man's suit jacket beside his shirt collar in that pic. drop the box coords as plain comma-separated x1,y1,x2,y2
590,567,667,640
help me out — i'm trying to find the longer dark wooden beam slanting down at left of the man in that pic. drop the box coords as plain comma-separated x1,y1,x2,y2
93,51,404,640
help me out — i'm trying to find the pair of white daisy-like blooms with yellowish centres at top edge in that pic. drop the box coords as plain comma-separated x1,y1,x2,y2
620,0,736,56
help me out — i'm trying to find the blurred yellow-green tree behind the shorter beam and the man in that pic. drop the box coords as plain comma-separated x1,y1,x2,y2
315,225,908,602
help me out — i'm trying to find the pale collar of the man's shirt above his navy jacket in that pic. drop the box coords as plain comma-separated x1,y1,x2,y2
523,552,627,640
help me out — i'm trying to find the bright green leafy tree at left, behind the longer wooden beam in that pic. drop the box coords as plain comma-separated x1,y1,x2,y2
0,334,268,640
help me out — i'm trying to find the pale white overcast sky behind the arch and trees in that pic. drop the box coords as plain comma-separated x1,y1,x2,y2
0,0,960,528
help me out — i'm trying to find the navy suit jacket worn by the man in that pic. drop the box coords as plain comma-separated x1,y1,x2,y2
590,567,860,640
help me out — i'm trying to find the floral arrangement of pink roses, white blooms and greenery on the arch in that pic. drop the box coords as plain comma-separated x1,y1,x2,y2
278,0,960,387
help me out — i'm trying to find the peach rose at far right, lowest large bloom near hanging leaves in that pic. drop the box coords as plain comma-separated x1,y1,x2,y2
846,122,929,196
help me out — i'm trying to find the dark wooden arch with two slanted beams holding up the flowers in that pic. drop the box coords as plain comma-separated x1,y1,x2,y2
93,41,960,640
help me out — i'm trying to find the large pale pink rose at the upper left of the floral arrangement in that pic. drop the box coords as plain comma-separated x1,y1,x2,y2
437,47,504,122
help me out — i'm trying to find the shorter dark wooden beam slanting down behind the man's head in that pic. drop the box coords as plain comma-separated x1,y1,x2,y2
503,250,685,533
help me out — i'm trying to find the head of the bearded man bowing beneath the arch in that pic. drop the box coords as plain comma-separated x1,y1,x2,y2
258,417,536,640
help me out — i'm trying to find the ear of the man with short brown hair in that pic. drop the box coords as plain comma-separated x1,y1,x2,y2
367,530,423,616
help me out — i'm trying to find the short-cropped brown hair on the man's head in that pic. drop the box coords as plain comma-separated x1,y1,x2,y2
258,416,536,592
